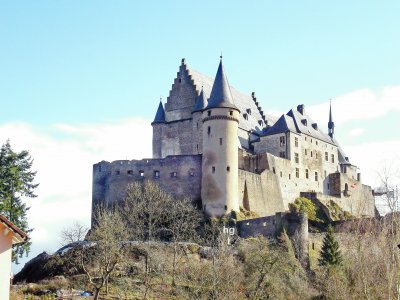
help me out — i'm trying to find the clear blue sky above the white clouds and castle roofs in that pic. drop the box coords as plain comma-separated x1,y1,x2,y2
0,0,400,130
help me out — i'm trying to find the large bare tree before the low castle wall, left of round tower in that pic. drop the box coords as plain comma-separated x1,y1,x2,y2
120,181,201,298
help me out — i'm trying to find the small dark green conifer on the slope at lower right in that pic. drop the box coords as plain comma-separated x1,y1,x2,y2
319,224,342,266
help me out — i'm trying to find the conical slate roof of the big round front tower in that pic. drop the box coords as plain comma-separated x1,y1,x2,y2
206,55,238,109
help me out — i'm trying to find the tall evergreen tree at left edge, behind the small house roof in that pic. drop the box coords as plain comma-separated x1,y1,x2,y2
0,140,38,263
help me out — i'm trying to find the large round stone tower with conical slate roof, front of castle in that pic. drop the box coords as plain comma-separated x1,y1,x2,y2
201,57,240,217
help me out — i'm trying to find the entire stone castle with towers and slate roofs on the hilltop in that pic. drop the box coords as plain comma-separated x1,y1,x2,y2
92,58,375,217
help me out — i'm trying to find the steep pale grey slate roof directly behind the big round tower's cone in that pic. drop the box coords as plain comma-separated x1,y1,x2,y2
186,64,276,134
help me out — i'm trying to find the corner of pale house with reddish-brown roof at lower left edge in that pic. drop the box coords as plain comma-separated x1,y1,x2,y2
0,215,27,300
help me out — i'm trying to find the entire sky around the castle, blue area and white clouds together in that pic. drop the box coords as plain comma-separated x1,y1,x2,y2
0,0,400,270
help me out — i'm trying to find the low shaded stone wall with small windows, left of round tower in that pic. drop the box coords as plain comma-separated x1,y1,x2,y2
92,155,202,216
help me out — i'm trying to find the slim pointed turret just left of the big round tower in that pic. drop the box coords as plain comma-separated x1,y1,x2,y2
192,88,207,154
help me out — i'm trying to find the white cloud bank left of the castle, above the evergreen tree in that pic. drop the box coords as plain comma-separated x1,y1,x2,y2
0,118,152,270
